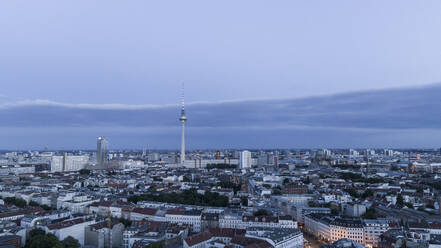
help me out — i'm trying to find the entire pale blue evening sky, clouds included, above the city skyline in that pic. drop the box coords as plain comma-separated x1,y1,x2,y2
0,0,441,149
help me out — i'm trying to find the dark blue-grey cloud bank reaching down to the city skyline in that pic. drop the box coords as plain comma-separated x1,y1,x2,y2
0,84,441,148
